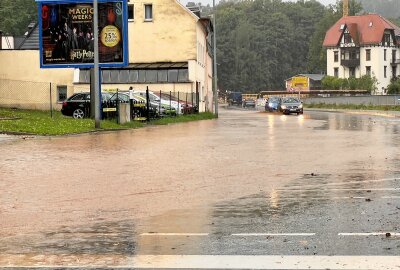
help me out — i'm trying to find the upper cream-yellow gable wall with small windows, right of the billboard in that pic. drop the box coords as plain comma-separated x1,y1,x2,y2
129,0,197,63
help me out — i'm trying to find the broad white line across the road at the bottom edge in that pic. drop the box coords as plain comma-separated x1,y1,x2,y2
0,255,400,270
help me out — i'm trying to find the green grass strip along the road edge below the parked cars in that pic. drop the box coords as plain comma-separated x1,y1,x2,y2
0,108,214,135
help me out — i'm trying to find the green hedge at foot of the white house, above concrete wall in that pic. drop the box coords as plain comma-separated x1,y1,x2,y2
322,75,377,92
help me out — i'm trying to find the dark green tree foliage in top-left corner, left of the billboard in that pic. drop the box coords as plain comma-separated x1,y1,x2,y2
0,0,37,35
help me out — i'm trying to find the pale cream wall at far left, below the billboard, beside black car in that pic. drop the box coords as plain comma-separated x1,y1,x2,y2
0,50,74,110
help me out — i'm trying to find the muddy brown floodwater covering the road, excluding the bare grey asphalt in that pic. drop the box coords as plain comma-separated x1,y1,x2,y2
0,110,400,266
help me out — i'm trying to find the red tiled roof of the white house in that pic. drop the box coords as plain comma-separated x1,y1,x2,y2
324,14,400,47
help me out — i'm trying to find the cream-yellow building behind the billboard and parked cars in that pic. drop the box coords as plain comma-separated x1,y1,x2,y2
0,0,213,111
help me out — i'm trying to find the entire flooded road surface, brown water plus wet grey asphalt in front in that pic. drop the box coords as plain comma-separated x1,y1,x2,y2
0,110,400,269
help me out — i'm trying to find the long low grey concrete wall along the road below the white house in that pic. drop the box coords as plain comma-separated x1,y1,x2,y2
303,95,400,106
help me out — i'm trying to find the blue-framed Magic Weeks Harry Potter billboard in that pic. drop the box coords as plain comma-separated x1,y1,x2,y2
38,0,128,68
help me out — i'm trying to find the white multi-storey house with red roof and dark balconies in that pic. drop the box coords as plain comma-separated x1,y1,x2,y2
324,14,400,94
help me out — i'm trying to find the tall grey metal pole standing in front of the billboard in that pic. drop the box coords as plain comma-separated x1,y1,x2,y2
93,0,101,128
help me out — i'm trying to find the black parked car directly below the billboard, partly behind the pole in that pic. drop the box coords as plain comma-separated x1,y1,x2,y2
61,92,111,119
